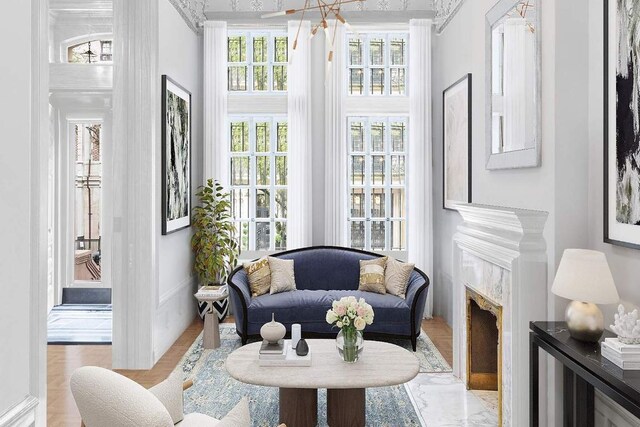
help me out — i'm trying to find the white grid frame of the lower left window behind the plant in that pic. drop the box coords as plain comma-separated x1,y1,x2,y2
227,114,289,260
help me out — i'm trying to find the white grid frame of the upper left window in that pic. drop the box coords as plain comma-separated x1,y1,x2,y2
227,29,289,96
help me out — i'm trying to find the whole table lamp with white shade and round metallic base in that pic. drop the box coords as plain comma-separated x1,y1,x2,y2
551,249,620,342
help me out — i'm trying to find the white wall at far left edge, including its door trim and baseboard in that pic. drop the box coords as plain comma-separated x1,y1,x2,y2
0,0,48,425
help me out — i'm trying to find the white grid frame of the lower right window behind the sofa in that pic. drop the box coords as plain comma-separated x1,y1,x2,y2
347,116,409,253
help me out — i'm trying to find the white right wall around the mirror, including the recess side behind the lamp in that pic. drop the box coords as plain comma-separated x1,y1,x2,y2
432,0,601,425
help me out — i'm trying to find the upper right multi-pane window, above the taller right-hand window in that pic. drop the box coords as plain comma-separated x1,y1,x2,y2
347,34,408,96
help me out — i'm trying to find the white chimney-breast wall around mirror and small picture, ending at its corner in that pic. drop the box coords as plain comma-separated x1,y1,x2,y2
432,0,555,324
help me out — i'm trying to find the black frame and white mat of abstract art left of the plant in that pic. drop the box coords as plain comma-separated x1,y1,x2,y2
161,74,193,235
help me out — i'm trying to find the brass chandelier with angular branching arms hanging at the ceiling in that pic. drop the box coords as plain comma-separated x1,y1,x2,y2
262,0,366,64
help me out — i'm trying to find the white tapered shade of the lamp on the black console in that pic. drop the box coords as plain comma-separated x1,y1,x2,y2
551,249,620,304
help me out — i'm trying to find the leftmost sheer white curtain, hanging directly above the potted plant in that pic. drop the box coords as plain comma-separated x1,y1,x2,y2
203,21,229,186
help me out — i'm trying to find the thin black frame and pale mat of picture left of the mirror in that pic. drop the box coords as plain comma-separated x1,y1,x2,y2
442,73,473,211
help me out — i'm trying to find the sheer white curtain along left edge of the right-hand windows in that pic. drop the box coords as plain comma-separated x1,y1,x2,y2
324,21,348,246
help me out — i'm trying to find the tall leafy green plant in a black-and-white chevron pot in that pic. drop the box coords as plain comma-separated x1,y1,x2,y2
191,179,240,317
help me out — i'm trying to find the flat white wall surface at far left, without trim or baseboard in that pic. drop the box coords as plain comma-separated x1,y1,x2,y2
0,1,33,415
